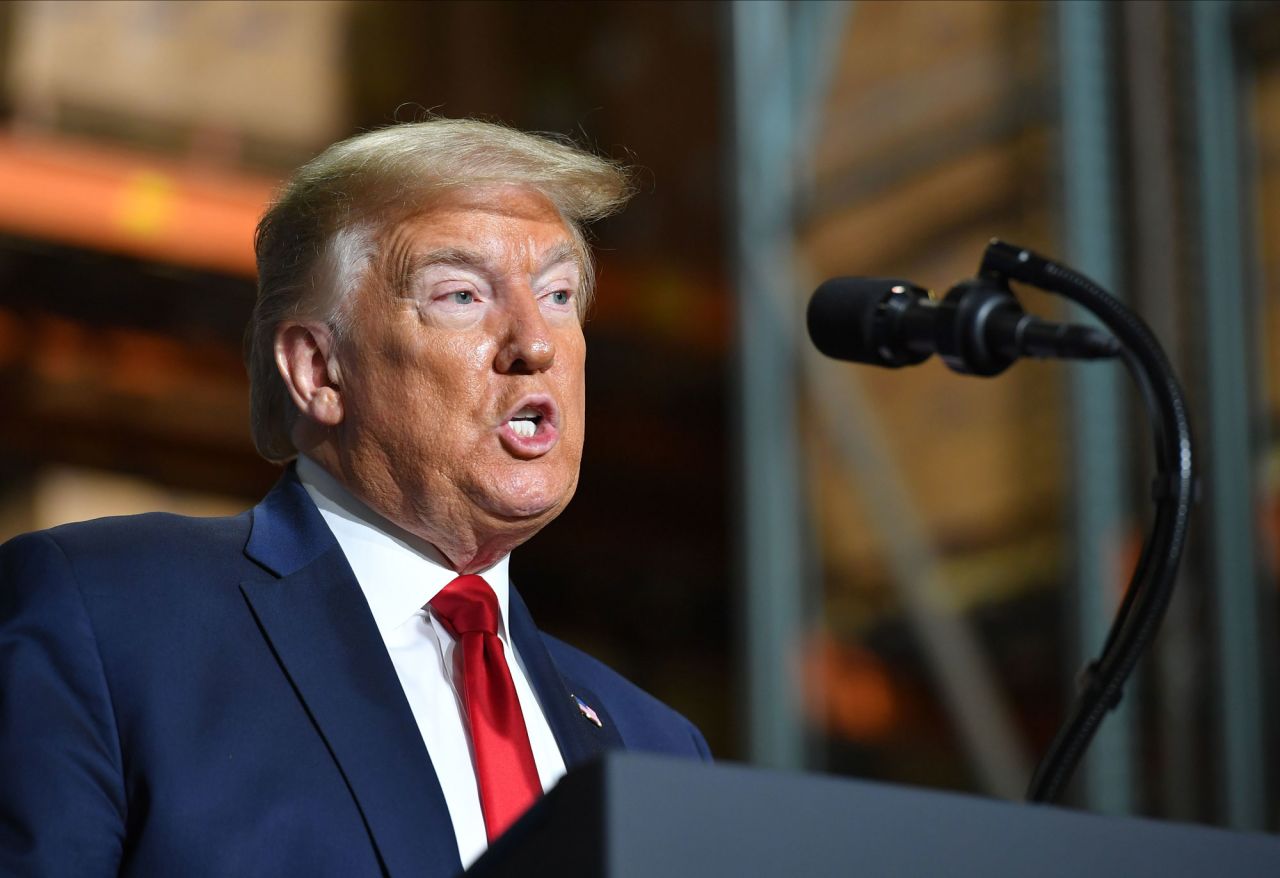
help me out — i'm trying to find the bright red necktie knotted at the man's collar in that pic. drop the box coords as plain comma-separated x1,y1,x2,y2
431,575,543,842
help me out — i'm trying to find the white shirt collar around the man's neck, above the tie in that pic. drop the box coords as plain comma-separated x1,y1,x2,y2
297,454,511,643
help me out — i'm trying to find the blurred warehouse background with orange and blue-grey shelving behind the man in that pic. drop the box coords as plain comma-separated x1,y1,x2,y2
0,0,1280,831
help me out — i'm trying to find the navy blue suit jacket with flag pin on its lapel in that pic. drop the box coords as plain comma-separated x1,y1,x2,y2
0,472,708,878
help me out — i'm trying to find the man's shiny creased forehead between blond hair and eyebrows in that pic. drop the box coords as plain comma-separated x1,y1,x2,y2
387,186,580,267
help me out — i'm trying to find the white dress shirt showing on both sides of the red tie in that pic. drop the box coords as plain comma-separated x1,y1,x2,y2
297,456,564,868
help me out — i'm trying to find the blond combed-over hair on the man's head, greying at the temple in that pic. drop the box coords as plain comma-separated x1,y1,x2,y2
244,119,632,462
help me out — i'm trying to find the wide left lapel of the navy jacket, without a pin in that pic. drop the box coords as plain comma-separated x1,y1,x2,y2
241,472,462,875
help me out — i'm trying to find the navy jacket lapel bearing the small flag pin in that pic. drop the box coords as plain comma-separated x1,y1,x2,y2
507,587,622,769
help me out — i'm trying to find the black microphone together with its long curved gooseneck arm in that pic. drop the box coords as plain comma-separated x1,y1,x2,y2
808,241,1196,802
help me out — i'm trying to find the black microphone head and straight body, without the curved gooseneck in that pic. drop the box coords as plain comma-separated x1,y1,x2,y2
808,278,1120,376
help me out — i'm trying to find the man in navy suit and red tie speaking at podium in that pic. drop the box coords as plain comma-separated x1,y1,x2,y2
0,120,708,877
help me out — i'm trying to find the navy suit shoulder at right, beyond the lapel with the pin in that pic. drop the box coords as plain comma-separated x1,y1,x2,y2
543,634,710,759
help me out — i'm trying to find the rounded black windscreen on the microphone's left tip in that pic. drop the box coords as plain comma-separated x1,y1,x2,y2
808,278,914,366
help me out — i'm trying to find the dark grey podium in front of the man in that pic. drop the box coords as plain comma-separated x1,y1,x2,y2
466,753,1280,878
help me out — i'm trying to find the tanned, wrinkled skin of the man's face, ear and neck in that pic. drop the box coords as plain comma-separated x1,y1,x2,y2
275,187,586,573
